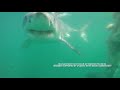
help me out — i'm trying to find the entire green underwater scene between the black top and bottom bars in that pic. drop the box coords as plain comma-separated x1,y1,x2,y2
0,12,120,78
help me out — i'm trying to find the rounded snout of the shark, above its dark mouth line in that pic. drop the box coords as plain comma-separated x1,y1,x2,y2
23,12,54,31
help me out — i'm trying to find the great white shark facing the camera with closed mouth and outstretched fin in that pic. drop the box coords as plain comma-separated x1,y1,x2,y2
23,12,87,55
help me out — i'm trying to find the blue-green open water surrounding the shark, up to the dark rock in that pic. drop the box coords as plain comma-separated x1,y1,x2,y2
0,12,112,78
